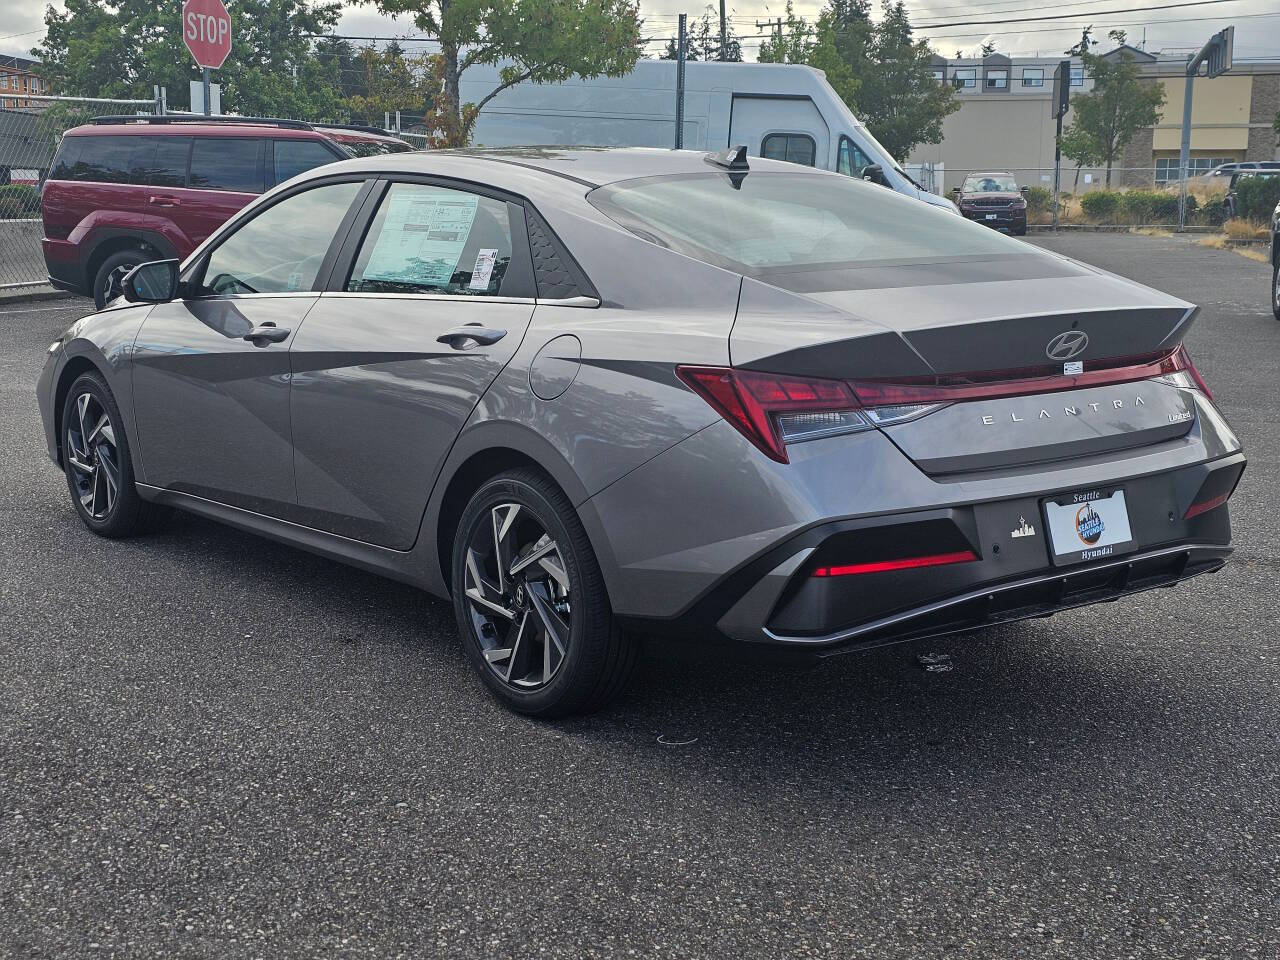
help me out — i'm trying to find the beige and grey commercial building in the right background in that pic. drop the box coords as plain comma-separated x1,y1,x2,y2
909,46,1280,192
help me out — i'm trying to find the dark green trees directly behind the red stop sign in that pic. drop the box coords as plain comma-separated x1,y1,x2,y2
32,0,342,118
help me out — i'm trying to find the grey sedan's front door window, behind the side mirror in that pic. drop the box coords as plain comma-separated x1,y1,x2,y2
201,181,364,296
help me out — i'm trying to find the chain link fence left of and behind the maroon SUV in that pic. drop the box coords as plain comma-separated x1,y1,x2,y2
0,93,159,291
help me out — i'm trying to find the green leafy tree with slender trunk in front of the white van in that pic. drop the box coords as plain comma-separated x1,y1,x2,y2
361,0,640,147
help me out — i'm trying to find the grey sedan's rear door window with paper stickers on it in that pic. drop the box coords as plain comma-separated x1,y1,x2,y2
346,183,512,296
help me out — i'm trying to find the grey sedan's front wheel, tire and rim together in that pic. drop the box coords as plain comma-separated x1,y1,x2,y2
61,372,163,539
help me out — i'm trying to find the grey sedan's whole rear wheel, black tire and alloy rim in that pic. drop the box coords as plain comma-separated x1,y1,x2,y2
452,470,636,718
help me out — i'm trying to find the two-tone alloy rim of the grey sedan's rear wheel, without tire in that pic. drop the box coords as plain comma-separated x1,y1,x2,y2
463,503,572,690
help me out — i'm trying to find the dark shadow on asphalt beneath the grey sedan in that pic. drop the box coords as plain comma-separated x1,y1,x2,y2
127,517,1228,796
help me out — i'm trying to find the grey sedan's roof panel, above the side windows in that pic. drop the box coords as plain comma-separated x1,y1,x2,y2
329,147,838,187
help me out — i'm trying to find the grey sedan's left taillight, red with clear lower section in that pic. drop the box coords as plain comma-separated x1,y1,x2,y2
676,366,937,463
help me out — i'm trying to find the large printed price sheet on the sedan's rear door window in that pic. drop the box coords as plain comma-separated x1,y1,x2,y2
364,189,481,287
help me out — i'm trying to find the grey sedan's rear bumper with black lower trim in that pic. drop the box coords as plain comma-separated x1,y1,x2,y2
584,417,1245,655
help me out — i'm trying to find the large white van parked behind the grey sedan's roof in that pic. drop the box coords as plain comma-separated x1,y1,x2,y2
461,60,956,212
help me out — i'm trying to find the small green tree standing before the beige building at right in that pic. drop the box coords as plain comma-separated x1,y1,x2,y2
1062,41,1165,187
